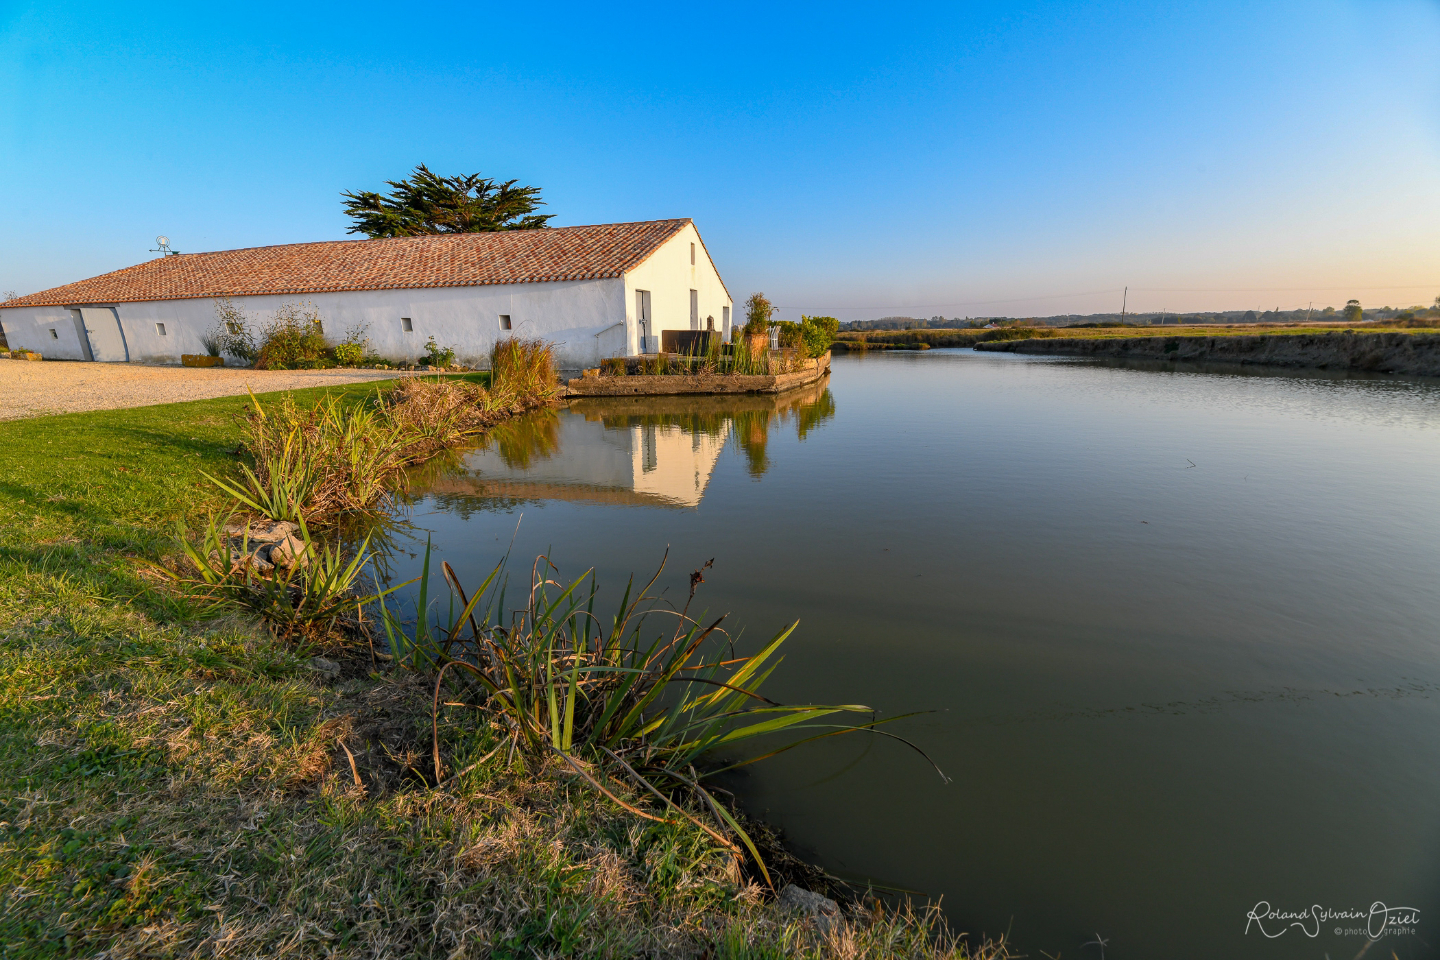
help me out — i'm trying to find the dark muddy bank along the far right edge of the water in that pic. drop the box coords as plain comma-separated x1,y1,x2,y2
975,331,1440,377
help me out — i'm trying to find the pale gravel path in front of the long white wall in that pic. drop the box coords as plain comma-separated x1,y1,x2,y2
0,360,417,420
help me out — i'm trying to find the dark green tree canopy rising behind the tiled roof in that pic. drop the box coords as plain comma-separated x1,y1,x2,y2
340,164,554,237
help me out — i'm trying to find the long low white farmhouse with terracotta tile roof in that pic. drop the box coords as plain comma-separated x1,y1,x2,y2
0,219,733,368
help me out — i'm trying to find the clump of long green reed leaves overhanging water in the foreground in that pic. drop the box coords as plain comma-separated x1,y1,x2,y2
382,550,943,879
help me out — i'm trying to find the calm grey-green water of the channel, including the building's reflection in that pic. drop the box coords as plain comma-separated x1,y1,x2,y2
394,350,1440,960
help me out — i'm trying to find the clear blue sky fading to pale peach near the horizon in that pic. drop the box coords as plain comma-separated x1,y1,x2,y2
0,0,1440,320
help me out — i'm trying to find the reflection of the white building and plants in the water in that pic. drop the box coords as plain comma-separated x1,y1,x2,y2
426,384,835,508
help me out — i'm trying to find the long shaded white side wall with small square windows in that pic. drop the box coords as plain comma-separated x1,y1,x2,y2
0,278,625,368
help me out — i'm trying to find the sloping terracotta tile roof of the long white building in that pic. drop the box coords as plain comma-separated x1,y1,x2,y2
0,219,690,309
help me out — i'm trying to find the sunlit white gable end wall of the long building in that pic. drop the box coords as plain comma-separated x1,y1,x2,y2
612,223,734,356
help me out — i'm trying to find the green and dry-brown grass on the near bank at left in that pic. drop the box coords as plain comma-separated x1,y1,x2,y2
0,384,996,960
